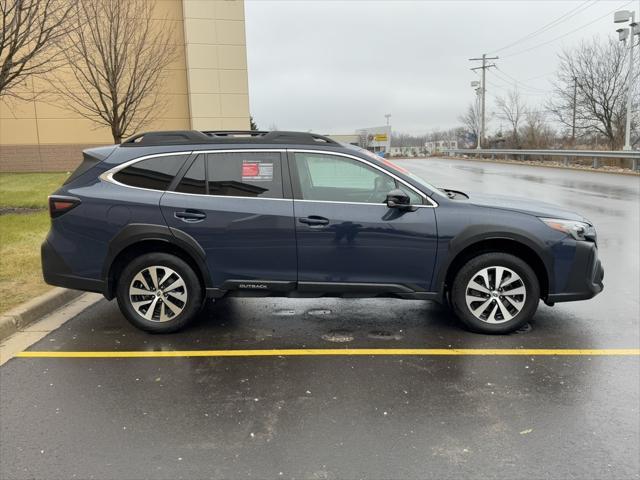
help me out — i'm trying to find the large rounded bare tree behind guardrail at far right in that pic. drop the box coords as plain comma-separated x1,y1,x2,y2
549,38,637,149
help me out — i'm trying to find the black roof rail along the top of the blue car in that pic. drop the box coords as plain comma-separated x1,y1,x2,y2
122,130,339,147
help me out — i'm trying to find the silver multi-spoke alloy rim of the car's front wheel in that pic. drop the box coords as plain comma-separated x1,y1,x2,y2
465,266,527,323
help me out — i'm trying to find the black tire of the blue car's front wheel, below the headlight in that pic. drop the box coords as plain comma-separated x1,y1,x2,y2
450,252,540,334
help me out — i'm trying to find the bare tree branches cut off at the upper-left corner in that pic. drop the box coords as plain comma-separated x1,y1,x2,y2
0,0,73,98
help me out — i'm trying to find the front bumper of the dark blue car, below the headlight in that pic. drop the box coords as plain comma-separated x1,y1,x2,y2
546,242,604,303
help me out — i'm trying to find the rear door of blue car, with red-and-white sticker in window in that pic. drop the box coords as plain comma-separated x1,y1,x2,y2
160,153,297,288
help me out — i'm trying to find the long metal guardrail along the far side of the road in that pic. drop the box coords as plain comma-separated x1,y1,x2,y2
443,148,640,171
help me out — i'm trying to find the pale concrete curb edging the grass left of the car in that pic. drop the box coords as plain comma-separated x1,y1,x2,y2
0,287,84,341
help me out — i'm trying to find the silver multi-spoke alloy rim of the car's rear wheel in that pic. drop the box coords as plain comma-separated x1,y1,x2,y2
129,266,187,322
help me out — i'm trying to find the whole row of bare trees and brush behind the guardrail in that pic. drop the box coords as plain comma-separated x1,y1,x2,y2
459,37,640,150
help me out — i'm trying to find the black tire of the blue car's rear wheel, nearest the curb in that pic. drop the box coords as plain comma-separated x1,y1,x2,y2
116,253,204,333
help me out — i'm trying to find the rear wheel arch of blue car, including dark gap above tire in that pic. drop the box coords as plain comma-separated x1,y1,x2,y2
102,224,211,300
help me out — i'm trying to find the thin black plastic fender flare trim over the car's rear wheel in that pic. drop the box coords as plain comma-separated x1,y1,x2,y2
102,223,212,298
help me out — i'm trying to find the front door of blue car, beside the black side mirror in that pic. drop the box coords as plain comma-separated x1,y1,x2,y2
289,152,437,291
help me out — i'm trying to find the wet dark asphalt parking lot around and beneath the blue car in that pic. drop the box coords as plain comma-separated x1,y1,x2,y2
0,160,640,479
